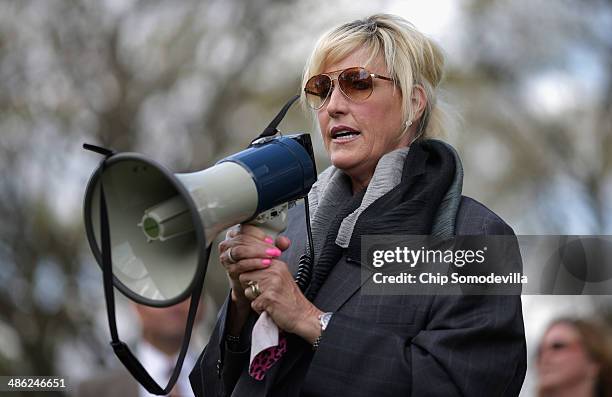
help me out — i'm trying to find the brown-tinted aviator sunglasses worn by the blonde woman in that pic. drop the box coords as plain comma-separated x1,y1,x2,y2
304,66,393,110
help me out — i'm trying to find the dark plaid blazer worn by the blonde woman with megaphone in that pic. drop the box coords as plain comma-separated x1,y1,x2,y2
190,197,527,397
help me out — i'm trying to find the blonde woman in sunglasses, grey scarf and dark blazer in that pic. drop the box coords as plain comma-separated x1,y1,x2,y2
191,15,526,396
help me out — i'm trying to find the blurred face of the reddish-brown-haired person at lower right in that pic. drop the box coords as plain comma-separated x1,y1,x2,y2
537,323,599,390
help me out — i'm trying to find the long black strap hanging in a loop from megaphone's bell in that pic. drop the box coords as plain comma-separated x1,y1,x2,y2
83,144,210,395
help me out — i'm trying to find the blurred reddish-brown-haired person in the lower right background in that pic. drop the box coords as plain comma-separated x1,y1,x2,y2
537,318,612,397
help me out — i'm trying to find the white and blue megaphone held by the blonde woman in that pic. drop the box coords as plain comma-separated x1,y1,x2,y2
84,134,316,307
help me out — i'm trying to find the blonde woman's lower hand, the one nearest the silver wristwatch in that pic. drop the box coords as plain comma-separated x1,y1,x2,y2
239,259,323,343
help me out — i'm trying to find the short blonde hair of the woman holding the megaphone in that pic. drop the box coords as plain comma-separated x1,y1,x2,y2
301,14,444,138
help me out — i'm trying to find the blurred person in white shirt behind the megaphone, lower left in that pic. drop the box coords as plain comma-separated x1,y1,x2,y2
76,299,205,397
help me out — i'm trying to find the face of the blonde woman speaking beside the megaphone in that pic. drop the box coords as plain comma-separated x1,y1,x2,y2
318,50,412,190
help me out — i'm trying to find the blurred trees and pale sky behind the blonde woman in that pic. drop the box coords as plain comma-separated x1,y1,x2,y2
0,0,612,395
